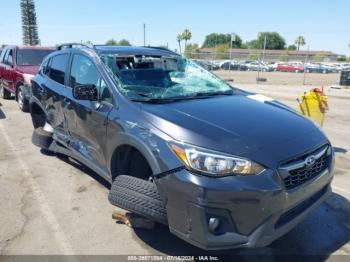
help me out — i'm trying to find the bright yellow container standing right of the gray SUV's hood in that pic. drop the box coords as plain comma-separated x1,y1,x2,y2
299,89,328,127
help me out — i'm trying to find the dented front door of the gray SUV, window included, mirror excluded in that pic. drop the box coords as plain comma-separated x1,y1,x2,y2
64,54,113,170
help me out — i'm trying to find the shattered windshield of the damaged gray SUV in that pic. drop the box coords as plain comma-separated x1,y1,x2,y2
102,55,232,102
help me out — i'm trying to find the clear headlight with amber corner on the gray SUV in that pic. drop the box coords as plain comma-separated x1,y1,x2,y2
170,144,264,176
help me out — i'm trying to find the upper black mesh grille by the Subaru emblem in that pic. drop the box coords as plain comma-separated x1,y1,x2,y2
283,154,327,189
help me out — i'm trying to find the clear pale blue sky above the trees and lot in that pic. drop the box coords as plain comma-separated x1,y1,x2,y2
0,0,350,55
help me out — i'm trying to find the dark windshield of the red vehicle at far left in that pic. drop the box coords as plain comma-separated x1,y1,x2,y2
17,49,53,66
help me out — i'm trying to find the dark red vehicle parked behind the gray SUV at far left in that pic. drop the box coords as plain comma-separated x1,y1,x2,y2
0,46,54,111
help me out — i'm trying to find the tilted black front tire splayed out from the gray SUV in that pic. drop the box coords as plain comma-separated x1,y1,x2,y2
108,175,168,225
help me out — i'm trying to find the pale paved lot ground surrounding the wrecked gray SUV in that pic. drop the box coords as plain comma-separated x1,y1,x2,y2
0,72,350,260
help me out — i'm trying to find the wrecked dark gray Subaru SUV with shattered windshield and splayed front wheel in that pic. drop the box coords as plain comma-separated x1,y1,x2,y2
30,44,334,250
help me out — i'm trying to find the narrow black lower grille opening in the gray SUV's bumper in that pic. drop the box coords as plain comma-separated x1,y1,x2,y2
275,185,328,228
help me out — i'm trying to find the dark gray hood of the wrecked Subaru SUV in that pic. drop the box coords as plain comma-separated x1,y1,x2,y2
142,95,327,168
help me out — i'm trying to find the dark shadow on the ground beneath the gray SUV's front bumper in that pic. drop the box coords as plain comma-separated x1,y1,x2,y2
135,193,350,261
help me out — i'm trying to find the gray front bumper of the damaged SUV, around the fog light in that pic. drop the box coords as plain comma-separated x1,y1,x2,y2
157,166,333,250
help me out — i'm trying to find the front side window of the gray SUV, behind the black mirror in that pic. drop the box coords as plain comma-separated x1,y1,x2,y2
69,55,113,104
